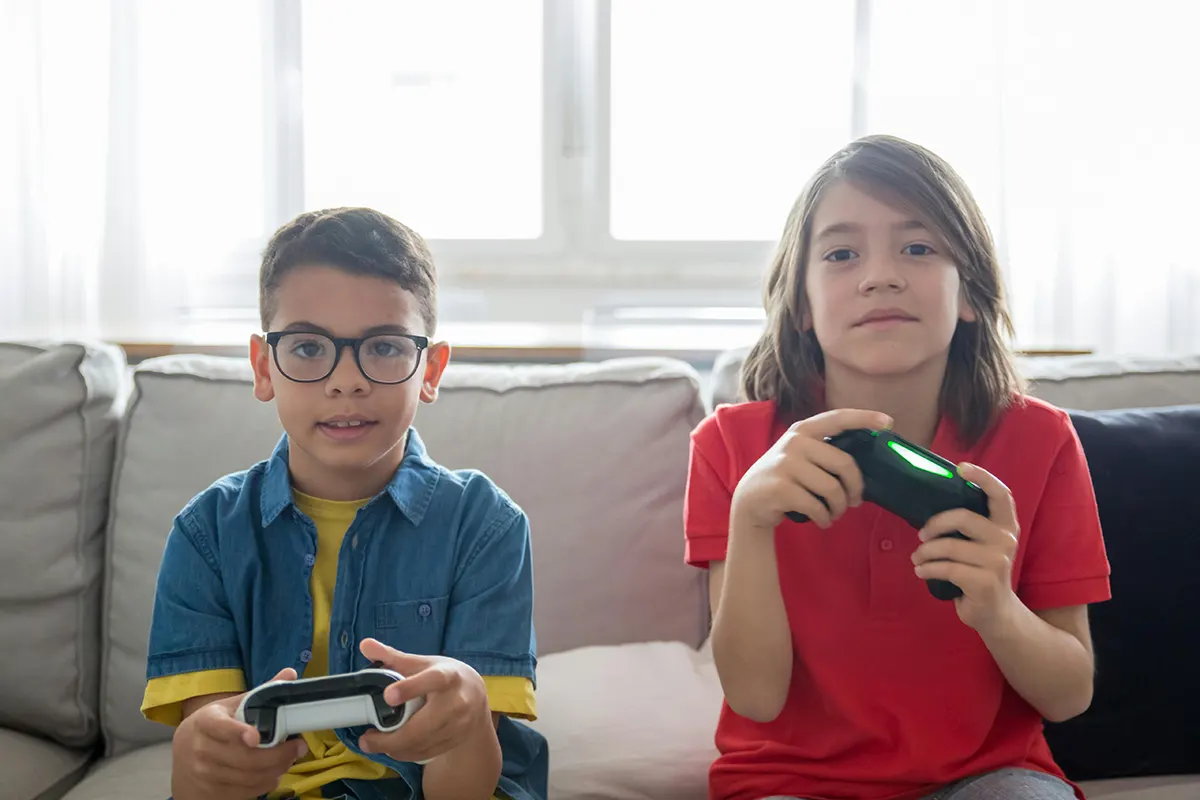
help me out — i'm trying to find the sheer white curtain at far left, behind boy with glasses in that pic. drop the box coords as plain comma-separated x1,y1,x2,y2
0,0,266,341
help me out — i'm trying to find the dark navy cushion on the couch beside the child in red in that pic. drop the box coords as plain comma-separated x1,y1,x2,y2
1046,405,1200,782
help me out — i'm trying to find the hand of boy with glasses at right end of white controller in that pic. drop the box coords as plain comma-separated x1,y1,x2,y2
359,639,494,762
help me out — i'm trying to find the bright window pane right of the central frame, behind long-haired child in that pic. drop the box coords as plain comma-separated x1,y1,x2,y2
614,0,854,241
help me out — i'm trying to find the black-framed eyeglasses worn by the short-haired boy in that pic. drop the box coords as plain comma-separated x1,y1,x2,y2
266,331,430,385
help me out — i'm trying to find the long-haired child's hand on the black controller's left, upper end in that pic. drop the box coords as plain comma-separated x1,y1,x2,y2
730,409,892,530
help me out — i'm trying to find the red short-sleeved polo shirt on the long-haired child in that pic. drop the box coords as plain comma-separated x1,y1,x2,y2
684,398,1110,800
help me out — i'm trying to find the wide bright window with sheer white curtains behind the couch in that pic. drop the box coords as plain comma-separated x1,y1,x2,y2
0,0,1200,351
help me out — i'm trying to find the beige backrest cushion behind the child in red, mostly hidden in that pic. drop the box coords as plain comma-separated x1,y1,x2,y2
708,348,1200,410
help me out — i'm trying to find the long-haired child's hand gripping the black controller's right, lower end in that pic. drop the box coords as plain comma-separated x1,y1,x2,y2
912,464,1020,633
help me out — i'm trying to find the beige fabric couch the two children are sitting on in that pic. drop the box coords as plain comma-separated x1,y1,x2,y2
0,343,1200,800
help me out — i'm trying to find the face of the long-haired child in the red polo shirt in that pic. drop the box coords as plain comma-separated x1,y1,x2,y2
805,182,974,375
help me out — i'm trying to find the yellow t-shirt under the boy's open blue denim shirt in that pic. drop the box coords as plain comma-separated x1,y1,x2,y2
142,491,536,800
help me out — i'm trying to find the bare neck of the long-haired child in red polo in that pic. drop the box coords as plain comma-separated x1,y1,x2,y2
826,359,946,447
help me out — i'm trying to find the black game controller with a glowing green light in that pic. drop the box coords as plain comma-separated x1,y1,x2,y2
787,428,988,600
